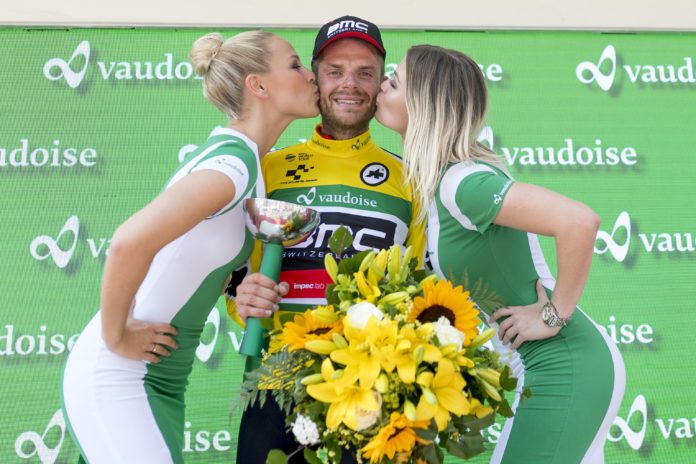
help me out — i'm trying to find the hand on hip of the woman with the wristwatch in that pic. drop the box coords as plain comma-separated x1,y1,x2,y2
489,280,561,350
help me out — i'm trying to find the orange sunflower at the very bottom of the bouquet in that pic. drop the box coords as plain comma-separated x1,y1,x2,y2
361,412,429,463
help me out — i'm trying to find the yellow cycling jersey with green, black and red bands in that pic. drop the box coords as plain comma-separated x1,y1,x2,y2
229,126,425,319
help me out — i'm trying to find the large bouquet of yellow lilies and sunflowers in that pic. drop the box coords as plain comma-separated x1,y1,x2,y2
242,229,517,464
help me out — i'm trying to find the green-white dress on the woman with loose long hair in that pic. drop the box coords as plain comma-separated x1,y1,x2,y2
428,162,625,464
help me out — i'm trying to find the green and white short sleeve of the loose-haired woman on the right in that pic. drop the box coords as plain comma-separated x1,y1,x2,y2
440,164,513,234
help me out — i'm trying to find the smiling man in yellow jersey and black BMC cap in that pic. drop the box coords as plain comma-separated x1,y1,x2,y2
229,16,425,463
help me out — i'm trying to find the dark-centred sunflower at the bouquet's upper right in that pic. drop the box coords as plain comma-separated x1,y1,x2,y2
408,279,481,346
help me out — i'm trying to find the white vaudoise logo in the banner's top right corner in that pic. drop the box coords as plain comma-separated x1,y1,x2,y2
575,45,696,92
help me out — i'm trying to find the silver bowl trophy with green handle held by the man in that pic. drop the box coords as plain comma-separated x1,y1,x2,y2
239,198,319,357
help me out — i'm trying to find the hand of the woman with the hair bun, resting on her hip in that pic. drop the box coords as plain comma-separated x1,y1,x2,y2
107,318,179,364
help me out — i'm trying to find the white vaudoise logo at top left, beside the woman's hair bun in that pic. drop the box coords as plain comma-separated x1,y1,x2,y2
43,40,200,89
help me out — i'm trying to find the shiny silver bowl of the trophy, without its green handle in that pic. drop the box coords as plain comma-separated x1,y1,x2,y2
244,198,319,247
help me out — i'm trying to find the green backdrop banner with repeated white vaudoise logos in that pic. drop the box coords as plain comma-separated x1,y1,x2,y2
0,28,696,463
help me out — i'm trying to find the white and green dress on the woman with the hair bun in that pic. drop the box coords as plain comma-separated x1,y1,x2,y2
62,128,265,464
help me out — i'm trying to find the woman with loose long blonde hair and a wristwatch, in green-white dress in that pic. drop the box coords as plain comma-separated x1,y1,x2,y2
376,45,625,464
